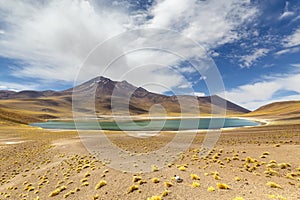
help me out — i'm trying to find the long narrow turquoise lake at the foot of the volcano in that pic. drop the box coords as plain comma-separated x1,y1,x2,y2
31,118,260,131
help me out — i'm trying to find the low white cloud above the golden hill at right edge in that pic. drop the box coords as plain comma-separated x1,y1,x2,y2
220,73,300,110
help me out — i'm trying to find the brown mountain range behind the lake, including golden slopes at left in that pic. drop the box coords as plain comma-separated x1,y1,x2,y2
0,76,250,119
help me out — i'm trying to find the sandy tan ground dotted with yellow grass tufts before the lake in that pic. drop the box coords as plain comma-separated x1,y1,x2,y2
0,119,300,200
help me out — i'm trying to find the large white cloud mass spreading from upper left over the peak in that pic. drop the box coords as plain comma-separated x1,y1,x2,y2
0,0,257,92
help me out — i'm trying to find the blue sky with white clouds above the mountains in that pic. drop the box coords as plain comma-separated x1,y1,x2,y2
0,0,300,110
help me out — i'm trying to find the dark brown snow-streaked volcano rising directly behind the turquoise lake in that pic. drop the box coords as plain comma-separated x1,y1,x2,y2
71,77,249,115
